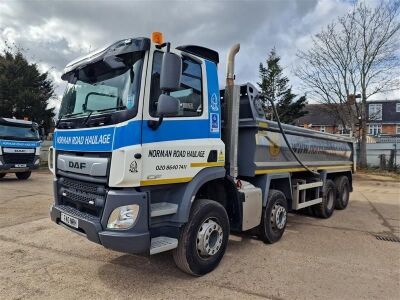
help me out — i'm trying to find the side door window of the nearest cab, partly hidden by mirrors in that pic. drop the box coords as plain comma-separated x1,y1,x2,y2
149,51,203,117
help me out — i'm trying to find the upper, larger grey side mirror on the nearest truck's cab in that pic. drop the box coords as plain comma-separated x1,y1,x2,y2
160,52,182,92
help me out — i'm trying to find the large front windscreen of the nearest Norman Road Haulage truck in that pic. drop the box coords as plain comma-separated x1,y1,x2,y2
59,53,143,119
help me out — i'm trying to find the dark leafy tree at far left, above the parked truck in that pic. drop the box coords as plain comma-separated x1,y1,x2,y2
0,48,54,132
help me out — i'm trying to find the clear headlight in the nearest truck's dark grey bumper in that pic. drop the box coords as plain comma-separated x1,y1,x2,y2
107,204,139,229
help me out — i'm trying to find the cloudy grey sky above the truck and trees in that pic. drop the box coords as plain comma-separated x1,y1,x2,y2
0,0,394,110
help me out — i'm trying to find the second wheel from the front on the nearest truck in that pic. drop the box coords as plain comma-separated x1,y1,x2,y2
258,190,288,244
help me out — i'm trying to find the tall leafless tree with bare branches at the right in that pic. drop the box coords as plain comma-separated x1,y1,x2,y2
296,1,400,167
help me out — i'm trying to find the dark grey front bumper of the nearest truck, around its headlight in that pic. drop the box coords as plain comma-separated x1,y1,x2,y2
50,182,150,254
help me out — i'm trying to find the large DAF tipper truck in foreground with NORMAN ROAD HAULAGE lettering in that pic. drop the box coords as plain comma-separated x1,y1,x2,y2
49,33,354,275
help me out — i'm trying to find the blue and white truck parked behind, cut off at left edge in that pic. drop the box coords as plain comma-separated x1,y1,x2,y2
0,118,41,179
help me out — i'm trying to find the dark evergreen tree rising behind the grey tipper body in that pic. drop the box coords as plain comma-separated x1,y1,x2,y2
257,48,307,124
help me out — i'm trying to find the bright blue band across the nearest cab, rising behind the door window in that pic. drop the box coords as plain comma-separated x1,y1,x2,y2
53,60,221,152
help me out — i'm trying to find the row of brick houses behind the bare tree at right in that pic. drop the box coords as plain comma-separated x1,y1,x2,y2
295,100,400,136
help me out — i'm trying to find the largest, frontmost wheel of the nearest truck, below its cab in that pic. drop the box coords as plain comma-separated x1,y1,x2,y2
173,199,230,276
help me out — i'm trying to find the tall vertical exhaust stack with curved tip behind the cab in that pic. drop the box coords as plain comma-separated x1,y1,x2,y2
223,44,240,178
